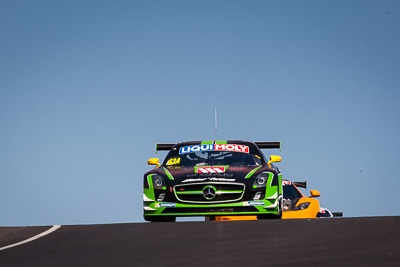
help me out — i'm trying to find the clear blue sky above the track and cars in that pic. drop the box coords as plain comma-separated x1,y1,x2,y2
0,0,400,226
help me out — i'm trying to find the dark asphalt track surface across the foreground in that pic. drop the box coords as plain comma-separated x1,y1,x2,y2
0,216,400,267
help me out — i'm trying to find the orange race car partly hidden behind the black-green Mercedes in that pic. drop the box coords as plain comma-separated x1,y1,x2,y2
209,180,320,221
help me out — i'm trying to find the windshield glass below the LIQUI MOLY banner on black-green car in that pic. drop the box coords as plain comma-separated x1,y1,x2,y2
165,151,262,167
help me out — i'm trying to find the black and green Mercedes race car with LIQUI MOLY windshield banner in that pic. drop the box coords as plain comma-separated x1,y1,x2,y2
143,140,283,222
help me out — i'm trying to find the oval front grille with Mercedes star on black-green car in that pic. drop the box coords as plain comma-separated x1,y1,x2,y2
174,182,245,204
